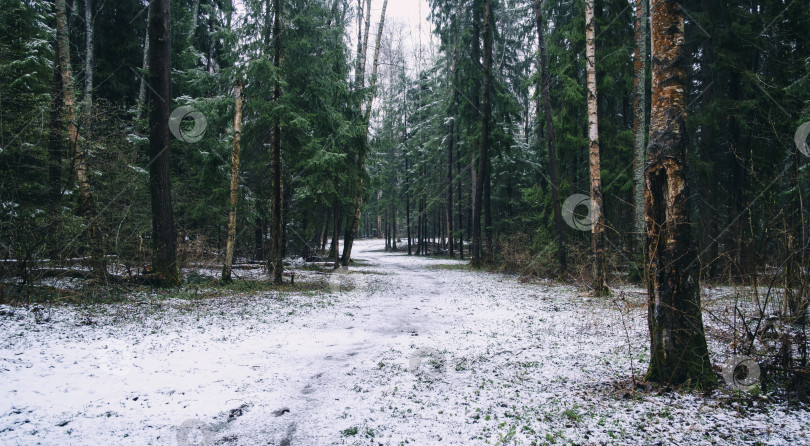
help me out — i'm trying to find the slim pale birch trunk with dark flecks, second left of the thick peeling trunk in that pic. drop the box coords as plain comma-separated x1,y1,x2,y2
585,0,607,296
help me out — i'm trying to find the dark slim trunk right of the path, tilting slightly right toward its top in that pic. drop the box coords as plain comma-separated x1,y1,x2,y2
471,0,492,268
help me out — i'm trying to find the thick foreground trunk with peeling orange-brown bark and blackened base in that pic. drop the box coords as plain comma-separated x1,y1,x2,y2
644,0,715,388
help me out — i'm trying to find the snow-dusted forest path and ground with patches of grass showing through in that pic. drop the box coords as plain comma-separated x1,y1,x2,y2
0,240,810,446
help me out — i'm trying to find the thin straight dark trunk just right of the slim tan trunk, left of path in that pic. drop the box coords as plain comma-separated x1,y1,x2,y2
270,0,284,284
